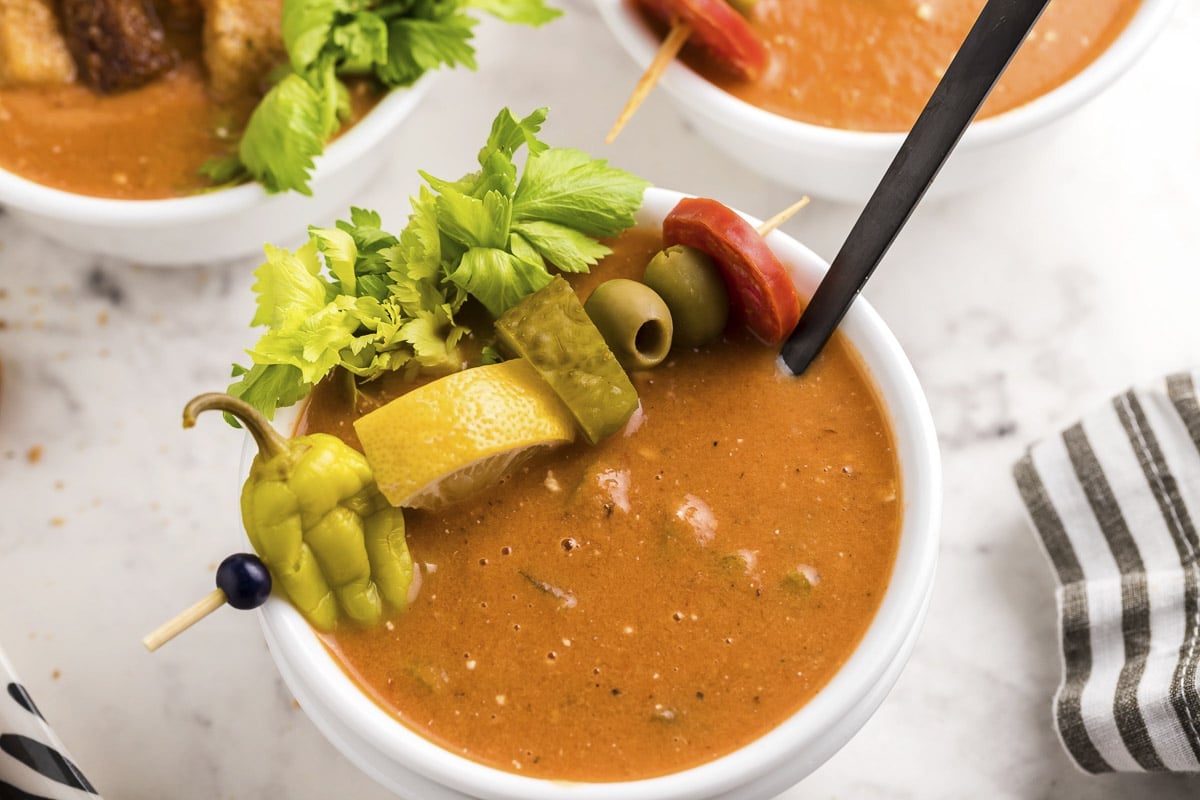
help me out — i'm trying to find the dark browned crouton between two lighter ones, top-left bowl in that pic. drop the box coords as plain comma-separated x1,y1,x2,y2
60,0,175,92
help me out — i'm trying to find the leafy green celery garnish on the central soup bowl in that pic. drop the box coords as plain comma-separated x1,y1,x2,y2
229,108,647,416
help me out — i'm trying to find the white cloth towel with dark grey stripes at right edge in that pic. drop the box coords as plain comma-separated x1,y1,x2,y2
1014,372,1200,772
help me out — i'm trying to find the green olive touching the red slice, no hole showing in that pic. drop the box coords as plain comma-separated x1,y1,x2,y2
642,245,730,348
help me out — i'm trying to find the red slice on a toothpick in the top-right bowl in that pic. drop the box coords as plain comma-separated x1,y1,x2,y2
637,0,768,80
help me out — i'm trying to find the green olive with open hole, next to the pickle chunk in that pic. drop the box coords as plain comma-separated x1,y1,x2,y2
583,278,672,369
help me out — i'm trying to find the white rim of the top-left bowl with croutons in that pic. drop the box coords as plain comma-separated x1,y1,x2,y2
0,72,433,228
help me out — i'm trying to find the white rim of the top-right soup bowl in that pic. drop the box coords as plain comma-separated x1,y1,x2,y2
595,0,1177,152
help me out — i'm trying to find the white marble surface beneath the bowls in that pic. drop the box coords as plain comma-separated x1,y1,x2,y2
0,0,1200,800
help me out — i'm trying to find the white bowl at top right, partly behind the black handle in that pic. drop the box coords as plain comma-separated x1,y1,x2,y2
595,0,1176,205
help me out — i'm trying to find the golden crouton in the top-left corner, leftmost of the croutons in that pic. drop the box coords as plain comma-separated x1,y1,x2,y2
0,0,76,86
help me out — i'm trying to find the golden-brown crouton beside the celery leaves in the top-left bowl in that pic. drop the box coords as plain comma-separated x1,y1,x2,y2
204,0,287,102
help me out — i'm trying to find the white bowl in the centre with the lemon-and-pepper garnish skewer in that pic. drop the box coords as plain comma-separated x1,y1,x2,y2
242,188,942,800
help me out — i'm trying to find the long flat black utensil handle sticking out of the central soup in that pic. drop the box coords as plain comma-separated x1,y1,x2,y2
781,0,1050,375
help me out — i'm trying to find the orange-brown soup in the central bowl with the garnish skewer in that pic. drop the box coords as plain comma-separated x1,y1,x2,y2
301,229,902,781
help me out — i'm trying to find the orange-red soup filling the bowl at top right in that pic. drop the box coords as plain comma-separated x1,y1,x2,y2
685,0,1140,131
